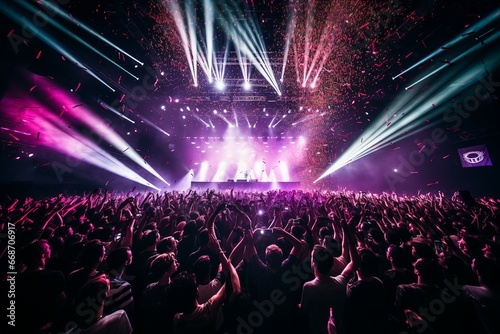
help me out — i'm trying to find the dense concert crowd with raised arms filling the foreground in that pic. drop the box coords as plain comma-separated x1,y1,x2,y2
0,190,500,334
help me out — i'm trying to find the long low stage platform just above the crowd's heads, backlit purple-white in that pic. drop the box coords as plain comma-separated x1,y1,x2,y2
191,181,300,191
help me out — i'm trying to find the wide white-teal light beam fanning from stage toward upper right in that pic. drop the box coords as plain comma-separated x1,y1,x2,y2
315,10,500,182
